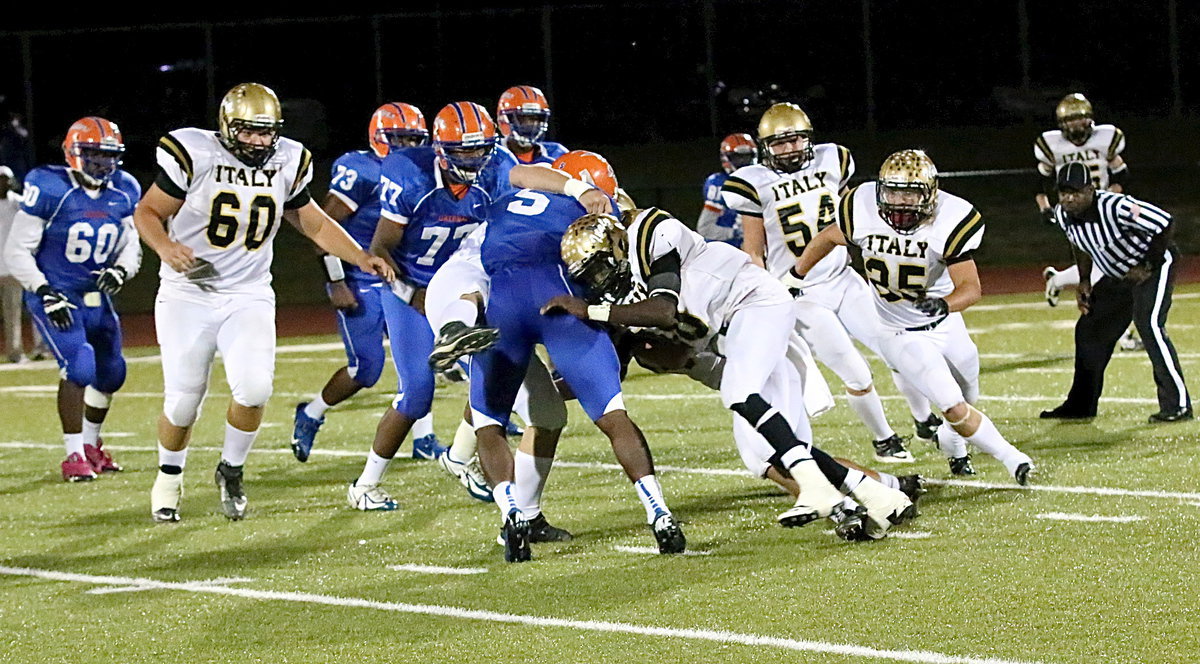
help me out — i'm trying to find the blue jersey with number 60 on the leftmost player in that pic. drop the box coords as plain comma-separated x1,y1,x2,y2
20,166,142,293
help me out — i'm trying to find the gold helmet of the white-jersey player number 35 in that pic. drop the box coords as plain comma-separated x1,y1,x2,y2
875,150,937,234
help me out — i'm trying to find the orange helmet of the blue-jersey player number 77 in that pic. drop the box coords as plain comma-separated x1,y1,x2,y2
433,101,496,184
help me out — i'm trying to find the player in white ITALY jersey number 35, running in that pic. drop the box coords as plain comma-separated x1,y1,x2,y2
794,150,1033,484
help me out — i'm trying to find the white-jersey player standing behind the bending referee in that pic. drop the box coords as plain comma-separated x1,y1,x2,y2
1033,92,1142,351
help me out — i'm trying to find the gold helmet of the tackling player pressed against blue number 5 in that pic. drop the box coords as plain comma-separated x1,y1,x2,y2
559,214,634,301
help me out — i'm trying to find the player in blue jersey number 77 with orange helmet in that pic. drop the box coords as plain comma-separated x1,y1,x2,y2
347,102,516,510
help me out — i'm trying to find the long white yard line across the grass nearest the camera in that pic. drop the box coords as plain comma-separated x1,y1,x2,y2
0,567,1033,664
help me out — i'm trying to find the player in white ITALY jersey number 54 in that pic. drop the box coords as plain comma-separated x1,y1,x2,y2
721,103,937,462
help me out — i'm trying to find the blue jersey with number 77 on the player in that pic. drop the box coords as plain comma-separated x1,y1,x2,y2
379,148,515,286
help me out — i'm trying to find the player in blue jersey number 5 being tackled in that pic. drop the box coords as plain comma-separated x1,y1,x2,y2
470,151,686,562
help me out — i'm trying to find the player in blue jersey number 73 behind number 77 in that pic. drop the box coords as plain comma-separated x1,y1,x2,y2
292,102,437,461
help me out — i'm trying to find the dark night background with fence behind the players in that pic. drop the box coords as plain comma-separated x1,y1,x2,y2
0,0,1200,309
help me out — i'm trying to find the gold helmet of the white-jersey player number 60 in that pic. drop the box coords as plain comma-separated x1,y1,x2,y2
217,83,283,168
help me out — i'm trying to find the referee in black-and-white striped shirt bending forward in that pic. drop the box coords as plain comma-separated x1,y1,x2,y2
1042,162,1193,423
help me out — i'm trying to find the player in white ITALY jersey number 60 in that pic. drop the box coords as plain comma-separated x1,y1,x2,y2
133,83,394,522
